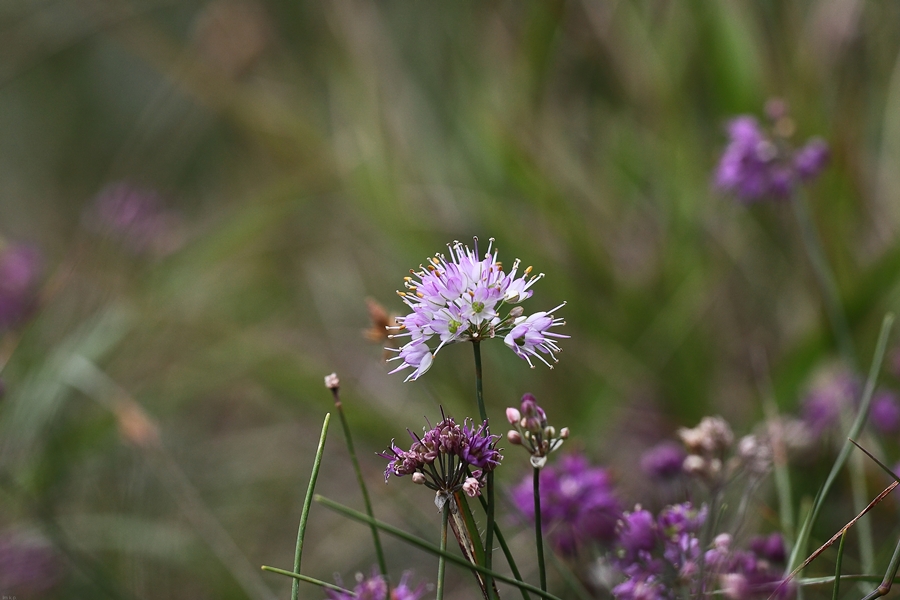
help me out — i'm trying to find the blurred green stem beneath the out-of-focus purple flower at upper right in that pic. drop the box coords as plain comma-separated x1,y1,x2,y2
791,188,857,370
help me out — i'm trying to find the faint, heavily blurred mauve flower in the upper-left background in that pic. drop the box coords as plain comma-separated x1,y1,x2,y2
84,182,180,254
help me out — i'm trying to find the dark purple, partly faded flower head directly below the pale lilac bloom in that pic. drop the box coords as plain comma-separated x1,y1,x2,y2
379,416,503,508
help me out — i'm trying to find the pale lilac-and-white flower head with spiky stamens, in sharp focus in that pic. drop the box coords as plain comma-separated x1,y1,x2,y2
388,238,568,381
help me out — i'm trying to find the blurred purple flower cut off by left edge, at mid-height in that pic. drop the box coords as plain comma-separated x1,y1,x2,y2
0,244,41,331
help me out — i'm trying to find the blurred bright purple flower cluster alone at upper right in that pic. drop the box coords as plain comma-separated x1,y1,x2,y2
714,103,829,203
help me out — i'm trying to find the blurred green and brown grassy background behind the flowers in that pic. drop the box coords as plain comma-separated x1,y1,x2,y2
0,0,900,598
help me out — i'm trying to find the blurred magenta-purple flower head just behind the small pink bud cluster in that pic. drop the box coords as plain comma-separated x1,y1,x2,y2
512,455,621,554
